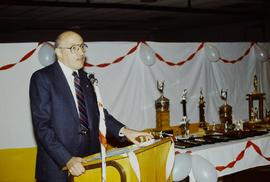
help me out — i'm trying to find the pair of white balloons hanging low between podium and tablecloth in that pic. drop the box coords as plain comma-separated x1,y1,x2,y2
172,153,218,182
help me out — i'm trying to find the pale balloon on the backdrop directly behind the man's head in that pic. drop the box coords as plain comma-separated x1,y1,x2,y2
38,42,55,66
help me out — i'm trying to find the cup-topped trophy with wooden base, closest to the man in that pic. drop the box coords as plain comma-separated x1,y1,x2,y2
155,80,170,130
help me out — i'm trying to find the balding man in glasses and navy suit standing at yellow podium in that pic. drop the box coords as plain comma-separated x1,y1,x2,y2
30,31,152,182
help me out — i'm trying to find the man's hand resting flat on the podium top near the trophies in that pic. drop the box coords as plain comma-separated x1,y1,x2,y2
122,128,154,144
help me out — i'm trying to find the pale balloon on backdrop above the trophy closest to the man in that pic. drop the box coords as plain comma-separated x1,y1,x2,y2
140,43,156,66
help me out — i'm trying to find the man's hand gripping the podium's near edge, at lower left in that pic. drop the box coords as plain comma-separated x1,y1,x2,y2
66,157,86,176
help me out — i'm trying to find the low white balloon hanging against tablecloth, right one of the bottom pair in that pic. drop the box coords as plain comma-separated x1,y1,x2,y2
192,155,217,182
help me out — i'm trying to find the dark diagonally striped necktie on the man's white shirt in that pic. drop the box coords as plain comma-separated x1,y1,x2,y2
72,71,88,134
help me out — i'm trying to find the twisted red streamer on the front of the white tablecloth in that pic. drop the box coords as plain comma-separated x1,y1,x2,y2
216,141,270,171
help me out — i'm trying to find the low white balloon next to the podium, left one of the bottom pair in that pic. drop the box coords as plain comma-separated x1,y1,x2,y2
172,153,191,181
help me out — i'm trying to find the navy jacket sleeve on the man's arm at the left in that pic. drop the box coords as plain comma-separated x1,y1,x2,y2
30,72,72,167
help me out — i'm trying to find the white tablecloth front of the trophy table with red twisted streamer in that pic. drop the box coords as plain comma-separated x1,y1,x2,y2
175,133,270,182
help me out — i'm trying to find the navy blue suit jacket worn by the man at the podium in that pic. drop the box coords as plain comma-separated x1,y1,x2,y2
30,61,124,182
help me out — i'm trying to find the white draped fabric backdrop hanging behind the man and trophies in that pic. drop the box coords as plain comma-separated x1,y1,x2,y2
0,42,270,148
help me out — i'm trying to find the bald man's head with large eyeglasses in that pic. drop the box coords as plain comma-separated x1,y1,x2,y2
55,31,87,70
